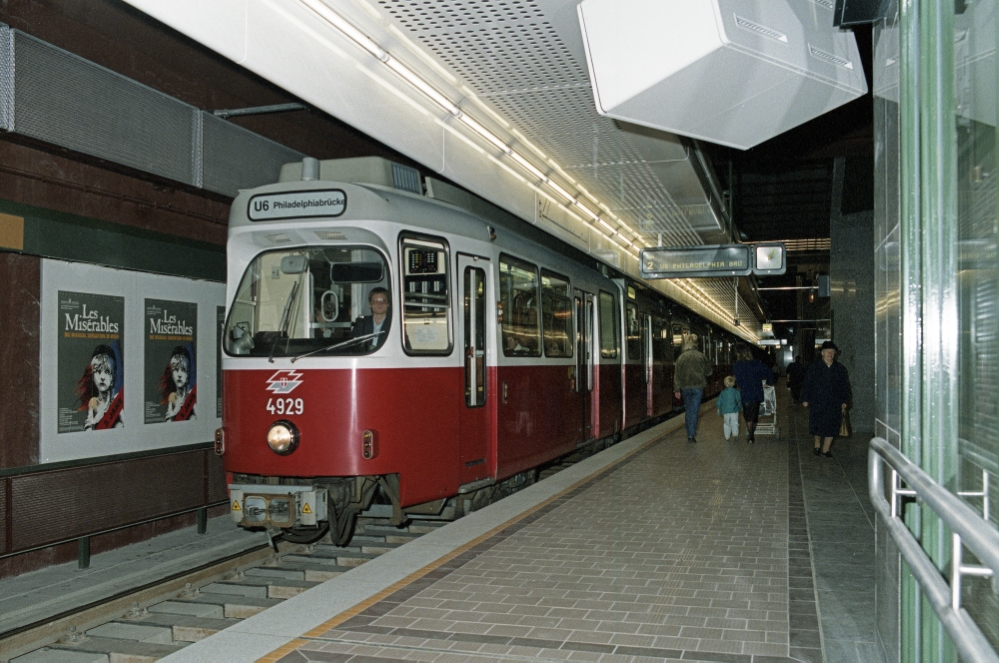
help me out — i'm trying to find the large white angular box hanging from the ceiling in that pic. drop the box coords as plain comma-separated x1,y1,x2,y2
578,0,867,149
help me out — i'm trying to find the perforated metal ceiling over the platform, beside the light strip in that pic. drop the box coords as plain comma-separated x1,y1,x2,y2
373,0,748,326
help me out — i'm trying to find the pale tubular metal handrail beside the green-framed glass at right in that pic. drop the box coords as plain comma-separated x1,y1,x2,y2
867,437,999,663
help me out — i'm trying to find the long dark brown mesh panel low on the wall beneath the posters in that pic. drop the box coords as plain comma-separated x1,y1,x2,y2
10,451,205,551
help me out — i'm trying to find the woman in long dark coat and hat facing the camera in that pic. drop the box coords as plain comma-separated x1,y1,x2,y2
801,341,850,458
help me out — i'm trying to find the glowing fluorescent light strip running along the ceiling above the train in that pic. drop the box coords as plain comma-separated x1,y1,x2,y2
299,0,758,340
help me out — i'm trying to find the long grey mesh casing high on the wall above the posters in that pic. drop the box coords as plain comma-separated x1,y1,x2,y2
0,24,305,196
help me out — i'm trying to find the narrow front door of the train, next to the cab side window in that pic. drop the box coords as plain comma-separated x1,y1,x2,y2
457,254,495,484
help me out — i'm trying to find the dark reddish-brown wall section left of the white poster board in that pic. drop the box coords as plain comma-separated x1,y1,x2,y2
0,253,41,469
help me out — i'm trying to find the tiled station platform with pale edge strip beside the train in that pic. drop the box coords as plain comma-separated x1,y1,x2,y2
154,386,880,663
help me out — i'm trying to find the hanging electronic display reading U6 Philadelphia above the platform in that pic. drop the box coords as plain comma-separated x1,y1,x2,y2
640,244,753,279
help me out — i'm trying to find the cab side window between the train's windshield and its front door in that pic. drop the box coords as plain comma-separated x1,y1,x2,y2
399,236,451,355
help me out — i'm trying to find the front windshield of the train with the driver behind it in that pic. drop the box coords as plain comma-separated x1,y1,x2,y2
225,246,392,358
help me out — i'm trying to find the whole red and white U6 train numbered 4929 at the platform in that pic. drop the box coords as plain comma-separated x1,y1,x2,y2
216,159,736,544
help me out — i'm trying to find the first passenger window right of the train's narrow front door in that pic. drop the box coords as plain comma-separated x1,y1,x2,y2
500,254,541,357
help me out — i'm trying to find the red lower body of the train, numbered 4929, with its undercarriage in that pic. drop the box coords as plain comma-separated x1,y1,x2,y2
220,352,725,545
